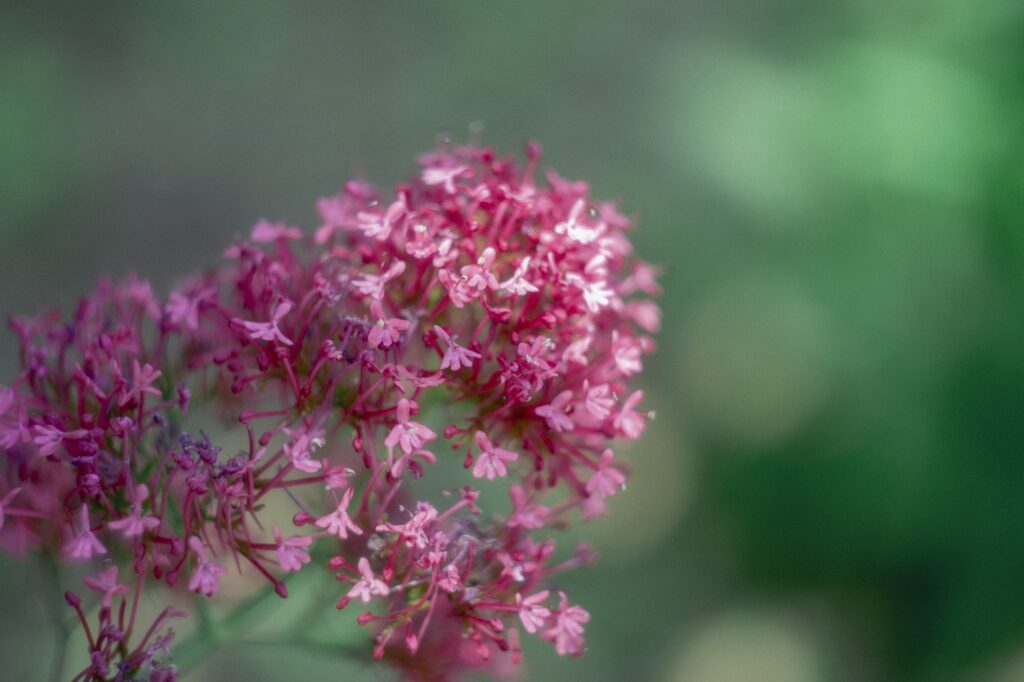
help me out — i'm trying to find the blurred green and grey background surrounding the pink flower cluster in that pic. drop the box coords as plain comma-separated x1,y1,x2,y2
0,0,1024,682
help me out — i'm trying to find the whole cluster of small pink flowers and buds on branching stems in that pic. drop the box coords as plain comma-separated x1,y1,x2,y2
0,143,659,680
